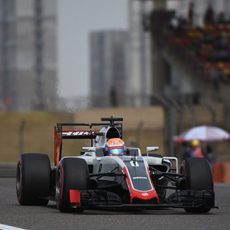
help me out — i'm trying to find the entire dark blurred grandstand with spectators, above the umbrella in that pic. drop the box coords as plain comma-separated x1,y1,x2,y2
146,1,230,156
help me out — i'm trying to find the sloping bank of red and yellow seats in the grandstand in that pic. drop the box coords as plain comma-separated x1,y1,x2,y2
168,13,230,101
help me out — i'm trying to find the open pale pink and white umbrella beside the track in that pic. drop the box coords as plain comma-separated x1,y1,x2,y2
174,125,230,142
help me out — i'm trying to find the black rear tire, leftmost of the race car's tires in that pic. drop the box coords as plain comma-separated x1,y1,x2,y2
16,153,51,206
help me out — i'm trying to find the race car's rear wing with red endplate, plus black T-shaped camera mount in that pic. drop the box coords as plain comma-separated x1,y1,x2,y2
54,116,123,165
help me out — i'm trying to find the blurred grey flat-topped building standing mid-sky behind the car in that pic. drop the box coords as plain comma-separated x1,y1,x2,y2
90,30,129,107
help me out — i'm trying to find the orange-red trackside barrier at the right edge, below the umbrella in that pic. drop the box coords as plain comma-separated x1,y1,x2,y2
213,162,230,183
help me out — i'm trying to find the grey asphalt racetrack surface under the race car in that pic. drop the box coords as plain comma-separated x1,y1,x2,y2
0,178,230,230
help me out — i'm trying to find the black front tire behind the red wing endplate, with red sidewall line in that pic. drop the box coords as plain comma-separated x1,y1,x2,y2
56,158,89,212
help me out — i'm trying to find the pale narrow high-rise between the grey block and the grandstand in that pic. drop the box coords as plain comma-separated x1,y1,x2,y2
127,0,152,106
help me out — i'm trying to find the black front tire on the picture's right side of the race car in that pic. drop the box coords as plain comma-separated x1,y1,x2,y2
181,158,214,213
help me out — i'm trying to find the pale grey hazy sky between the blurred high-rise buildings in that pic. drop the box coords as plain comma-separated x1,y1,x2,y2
58,0,128,97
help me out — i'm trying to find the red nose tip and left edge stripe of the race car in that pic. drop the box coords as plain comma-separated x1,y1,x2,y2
124,167,159,203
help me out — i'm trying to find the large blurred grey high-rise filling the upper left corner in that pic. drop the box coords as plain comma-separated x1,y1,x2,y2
0,0,57,110
